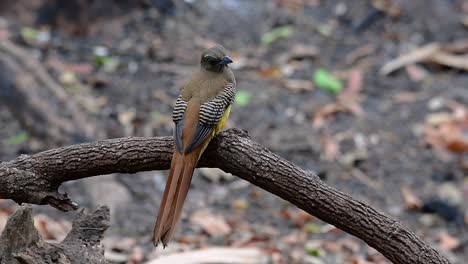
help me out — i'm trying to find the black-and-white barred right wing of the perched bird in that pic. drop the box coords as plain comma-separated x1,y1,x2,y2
185,83,236,153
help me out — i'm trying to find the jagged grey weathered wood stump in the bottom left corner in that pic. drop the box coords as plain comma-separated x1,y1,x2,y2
0,206,109,264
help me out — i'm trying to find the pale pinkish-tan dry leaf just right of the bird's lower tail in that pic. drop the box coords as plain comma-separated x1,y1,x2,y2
190,210,232,237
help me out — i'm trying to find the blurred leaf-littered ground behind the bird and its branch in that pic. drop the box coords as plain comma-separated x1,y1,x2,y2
0,0,468,264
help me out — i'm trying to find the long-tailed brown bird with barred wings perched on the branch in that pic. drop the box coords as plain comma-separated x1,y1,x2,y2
153,45,236,248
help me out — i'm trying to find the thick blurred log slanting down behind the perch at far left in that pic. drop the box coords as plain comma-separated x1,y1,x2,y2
0,40,102,145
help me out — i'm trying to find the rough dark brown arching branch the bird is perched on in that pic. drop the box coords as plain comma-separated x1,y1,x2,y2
0,129,448,264
